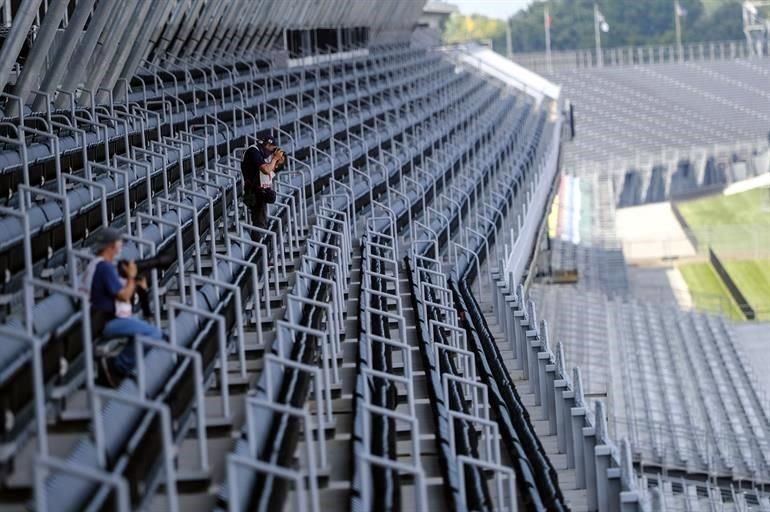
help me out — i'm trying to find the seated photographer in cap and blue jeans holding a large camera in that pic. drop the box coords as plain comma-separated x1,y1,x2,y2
84,228,164,387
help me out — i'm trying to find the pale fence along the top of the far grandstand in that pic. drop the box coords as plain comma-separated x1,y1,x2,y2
513,41,752,73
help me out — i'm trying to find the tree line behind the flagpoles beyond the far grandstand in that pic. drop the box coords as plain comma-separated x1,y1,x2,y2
444,0,743,53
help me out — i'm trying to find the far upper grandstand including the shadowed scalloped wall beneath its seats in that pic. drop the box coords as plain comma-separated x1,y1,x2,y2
553,58,770,208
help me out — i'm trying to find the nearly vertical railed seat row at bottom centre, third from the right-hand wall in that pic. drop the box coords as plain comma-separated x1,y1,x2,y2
351,229,404,510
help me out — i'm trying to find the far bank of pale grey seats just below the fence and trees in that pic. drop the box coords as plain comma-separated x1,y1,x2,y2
552,58,770,162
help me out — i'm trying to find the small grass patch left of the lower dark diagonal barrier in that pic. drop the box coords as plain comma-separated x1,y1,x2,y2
679,263,743,320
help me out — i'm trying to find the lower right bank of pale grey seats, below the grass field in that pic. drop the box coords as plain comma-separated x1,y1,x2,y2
531,285,769,479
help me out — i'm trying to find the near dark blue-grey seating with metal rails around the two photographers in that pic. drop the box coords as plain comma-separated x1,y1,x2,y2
2,29,632,510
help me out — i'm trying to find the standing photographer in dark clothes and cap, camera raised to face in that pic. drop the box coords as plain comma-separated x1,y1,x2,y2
241,136,286,233
